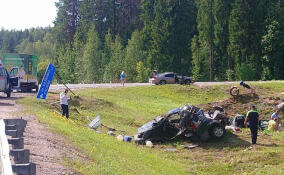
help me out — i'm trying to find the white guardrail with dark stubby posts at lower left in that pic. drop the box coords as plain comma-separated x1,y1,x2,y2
0,119,36,175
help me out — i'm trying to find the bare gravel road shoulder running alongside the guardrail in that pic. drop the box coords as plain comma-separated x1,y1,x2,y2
0,93,85,175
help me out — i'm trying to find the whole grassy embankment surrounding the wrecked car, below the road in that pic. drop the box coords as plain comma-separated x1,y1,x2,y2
20,83,284,174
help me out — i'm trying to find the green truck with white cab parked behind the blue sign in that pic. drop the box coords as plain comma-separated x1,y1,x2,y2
0,53,38,92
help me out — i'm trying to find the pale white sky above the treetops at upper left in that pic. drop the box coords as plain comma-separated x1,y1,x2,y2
0,0,59,30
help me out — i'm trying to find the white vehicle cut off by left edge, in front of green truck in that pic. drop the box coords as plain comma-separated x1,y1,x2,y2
0,60,11,97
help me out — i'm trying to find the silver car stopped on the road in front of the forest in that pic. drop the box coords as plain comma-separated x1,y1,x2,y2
149,72,193,85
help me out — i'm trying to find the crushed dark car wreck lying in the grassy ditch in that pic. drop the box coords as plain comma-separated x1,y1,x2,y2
134,104,228,144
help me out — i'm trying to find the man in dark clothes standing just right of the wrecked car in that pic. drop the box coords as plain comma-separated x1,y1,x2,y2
244,105,259,145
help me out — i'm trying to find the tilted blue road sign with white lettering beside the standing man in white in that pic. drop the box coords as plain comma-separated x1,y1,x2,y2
36,63,56,99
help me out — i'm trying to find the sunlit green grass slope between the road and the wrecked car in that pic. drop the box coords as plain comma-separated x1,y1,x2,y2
78,85,231,134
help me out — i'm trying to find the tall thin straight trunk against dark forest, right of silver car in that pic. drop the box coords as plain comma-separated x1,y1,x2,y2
210,0,214,81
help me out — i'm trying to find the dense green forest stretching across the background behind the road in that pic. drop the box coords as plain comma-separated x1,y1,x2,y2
0,0,284,83
